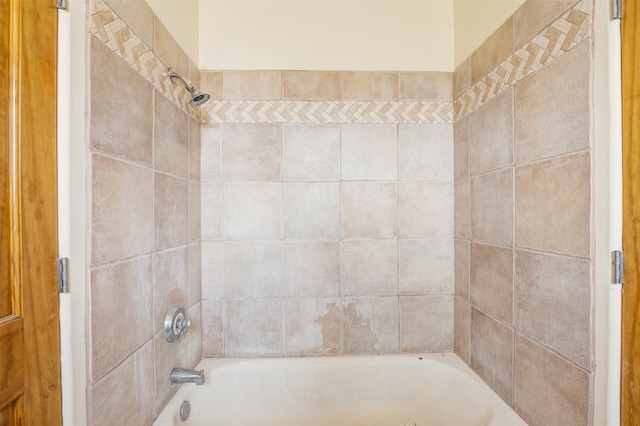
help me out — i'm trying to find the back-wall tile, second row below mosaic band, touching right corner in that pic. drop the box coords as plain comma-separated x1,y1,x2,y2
398,182,454,237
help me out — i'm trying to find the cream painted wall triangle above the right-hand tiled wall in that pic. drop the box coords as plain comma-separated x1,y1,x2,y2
453,0,525,67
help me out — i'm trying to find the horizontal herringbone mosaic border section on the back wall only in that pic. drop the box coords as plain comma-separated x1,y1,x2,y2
203,101,453,124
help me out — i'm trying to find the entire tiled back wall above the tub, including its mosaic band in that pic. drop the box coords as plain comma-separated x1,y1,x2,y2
201,71,454,356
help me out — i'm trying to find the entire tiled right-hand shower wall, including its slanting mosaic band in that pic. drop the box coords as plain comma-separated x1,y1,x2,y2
454,1,594,425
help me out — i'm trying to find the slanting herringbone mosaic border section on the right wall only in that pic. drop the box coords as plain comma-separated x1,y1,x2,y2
454,0,592,121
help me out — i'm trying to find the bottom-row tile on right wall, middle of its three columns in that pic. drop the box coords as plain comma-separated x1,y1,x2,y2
471,308,514,404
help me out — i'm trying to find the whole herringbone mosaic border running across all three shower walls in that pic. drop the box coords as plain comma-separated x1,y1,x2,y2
91,0,592,124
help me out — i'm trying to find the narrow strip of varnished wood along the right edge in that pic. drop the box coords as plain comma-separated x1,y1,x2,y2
620,0,640,426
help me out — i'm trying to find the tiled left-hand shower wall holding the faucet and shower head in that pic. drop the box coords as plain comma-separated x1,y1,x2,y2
87,1,202,426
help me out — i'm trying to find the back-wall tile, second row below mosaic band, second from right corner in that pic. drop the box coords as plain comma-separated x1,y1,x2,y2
341,182,398,238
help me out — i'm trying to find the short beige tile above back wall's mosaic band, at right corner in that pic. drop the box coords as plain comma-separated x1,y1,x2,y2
398,71,453,101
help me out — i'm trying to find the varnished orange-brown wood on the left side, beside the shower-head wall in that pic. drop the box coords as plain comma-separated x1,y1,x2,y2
0,0,62,426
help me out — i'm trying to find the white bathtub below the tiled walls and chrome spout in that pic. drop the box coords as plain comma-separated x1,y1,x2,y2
154,354,526,426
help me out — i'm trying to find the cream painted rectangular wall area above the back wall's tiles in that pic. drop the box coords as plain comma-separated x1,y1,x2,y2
200,0,453,71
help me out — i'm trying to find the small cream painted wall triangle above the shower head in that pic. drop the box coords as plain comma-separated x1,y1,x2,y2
146,0,202,64
